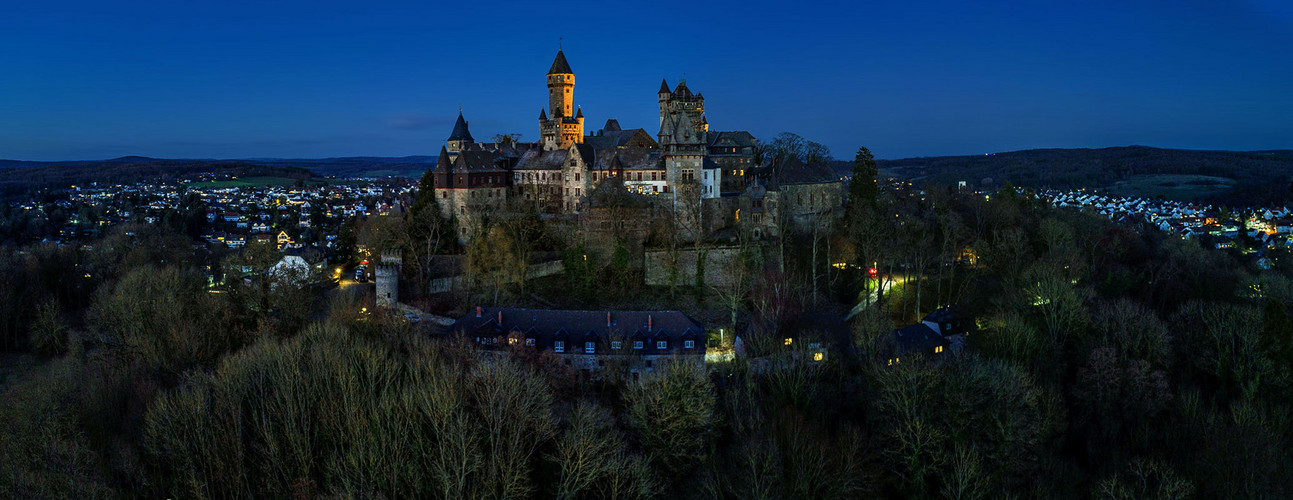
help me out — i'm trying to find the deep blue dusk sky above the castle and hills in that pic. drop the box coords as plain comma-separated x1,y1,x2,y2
0,0,1293,160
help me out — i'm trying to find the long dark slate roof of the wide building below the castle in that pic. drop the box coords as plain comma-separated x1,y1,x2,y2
449,307,705,355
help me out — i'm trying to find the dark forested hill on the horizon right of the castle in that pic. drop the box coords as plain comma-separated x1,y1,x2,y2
878,146,1293,205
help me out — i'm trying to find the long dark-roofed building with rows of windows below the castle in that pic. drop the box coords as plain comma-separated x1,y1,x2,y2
449,306,705,375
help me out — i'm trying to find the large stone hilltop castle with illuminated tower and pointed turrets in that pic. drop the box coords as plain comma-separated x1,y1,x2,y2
434,50,843,240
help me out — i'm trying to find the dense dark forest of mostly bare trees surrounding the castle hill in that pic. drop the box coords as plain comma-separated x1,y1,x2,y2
0,155,1293,499
